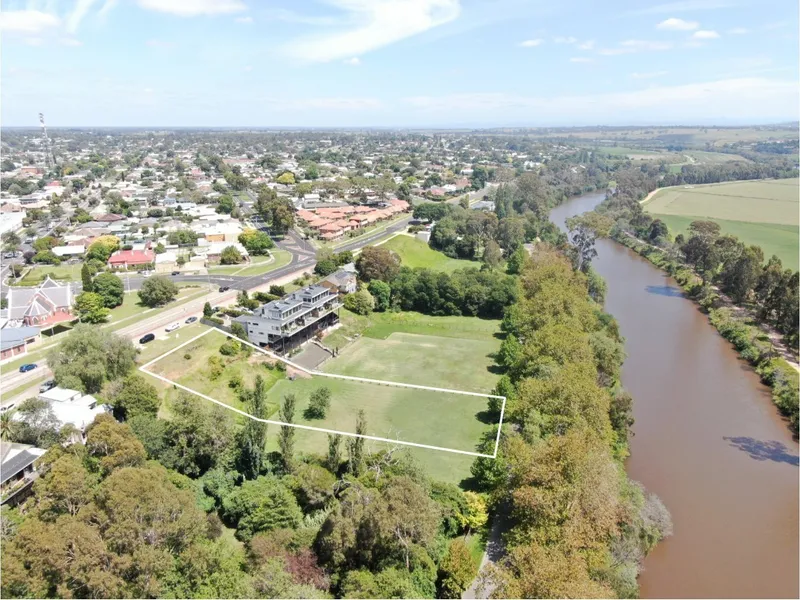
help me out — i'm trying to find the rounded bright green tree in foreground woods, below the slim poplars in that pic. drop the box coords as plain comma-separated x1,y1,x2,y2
222,475,303,540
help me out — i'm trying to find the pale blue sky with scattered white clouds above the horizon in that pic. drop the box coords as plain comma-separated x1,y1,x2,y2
0,0,800,127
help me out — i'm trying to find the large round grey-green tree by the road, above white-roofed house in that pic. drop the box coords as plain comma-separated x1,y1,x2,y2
47,323,136,394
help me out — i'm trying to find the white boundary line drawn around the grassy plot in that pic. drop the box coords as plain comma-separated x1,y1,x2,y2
139,327,506,458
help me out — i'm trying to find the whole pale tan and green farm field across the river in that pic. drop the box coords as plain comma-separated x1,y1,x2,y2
644,179,800,269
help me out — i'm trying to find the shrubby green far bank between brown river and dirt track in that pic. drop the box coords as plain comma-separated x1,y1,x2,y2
612,233,800,436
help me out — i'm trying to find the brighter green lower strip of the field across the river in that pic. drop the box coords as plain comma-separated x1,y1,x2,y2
653,214,800,271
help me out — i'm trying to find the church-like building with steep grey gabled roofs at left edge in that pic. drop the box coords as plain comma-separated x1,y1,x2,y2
0,276,74,329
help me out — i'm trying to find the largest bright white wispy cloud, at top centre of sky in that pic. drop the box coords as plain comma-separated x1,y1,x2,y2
282,0,461,62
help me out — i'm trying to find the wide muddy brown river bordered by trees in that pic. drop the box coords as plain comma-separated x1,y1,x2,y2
551,194,800,598
